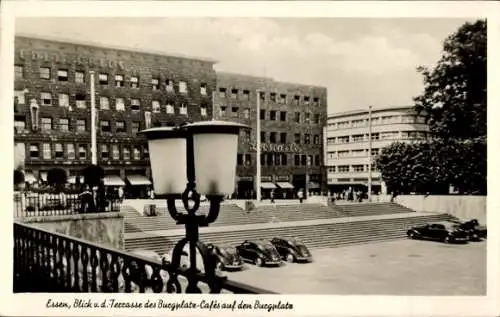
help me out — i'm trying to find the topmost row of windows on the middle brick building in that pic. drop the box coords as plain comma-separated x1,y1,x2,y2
219,87,320,106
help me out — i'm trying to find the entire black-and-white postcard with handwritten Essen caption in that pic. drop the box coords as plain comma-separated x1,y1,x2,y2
2,1,498,316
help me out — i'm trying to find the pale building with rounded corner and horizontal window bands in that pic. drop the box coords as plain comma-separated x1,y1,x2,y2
326,107,429,192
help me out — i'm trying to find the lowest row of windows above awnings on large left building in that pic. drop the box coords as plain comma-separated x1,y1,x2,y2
29,143,149,160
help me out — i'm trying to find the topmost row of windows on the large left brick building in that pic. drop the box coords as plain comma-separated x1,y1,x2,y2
14,65,208,95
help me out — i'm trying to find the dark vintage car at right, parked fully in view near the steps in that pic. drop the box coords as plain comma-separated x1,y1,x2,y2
406,221,469,243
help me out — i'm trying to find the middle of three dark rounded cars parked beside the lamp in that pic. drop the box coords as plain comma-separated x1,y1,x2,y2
236,240,281,266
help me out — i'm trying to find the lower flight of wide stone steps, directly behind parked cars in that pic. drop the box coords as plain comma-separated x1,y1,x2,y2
125,214,453,254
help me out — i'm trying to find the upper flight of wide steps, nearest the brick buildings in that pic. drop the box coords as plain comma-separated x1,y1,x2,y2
122,203,412,233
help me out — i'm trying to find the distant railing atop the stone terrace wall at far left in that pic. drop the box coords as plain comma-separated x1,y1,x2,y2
14,192,120,218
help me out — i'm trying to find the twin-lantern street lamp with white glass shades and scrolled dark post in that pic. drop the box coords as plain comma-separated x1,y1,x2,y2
140,121,248,293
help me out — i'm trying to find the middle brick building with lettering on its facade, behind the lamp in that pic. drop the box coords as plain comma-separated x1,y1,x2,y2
213,72,327,198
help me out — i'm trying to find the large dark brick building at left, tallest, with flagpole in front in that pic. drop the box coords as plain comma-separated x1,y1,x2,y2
14,36,216,196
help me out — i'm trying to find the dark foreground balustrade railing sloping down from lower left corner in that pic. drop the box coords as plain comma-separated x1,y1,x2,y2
14,222,273,294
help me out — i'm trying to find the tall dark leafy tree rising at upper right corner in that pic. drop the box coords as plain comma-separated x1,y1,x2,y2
414,20,487,139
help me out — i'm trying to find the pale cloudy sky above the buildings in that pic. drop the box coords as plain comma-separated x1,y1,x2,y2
16,18,466,113
